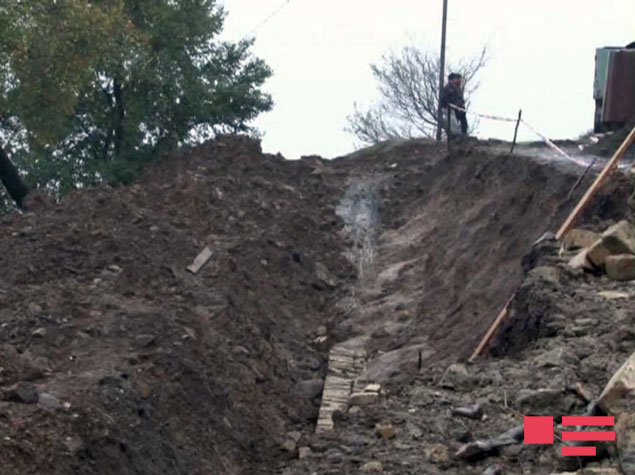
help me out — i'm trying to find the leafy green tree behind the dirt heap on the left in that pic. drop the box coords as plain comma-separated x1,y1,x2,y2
0,0,272,207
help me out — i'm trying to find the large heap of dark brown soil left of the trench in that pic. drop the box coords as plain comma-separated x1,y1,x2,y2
0,138,353,475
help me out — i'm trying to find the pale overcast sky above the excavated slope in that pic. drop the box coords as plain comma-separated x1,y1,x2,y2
221,0,635,158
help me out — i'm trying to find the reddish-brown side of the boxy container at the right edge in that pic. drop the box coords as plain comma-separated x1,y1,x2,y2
603,50,635,122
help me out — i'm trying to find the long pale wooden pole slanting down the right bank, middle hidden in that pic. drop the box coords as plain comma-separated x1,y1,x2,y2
468,127,635,363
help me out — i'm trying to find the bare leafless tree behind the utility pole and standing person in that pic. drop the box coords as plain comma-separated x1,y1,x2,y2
346,46,487,144
